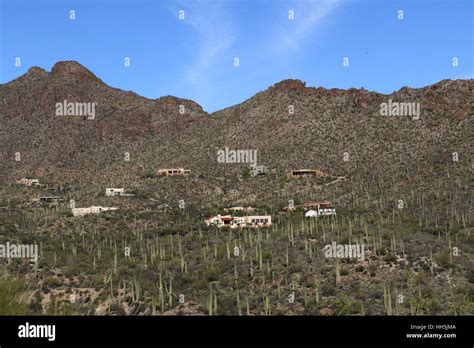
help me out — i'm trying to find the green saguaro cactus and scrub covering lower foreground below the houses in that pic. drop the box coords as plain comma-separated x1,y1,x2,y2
0,162,474,315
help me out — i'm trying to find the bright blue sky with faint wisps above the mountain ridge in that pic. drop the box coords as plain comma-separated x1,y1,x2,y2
0,0,474,111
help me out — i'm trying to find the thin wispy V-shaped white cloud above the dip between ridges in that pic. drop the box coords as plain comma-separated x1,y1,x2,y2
171,0,343,110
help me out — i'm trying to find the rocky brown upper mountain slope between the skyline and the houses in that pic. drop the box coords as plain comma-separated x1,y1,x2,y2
0,62,474,207
